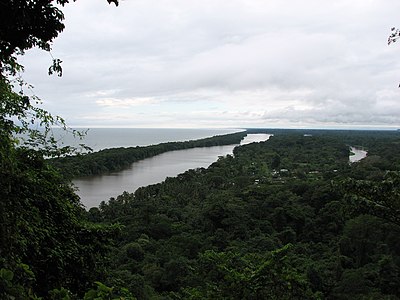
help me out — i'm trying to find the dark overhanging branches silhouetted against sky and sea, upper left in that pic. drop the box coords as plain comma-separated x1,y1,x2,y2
0,0,118,156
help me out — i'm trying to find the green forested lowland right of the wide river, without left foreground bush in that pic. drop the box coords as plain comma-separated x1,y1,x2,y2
88,131,400,299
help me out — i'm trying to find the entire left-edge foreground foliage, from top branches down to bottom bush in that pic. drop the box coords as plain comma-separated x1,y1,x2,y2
0,0,122,299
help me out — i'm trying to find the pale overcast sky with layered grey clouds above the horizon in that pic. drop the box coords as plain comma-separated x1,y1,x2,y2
21,0,400,128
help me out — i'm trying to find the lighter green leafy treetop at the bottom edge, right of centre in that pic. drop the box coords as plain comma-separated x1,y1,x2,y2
185,245,318,299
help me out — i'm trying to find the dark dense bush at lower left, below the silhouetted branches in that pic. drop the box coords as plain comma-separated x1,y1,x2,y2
0,137,122,295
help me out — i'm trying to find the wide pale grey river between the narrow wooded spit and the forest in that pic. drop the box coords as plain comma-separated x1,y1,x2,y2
73,134,270,208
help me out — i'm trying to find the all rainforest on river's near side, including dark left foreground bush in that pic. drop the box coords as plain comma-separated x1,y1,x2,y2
0,129,400,299
